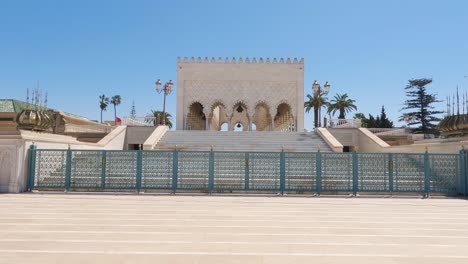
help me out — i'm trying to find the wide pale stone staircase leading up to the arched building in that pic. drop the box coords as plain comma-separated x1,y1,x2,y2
155,130,332,152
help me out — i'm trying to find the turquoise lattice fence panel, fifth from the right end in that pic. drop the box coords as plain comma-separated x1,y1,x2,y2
285,152,317,192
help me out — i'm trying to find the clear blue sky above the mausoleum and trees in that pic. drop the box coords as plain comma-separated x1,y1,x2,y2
0,0,468,129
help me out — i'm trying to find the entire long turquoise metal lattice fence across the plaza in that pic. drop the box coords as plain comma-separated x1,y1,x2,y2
28,146,468,195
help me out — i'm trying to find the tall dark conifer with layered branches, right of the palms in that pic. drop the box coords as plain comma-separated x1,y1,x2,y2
399,78,443,136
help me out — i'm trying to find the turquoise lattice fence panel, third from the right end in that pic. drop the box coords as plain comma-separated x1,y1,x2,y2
356,153,390,192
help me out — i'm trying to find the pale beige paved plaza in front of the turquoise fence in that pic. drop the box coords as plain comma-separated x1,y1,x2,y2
0,193,468,264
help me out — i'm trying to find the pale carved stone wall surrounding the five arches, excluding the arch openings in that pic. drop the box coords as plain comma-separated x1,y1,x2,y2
176,58,304,131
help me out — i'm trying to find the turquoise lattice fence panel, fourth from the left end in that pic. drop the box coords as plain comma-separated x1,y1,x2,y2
141,150,173,190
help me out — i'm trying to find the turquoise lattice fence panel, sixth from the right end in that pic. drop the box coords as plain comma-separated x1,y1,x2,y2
249,152,280,191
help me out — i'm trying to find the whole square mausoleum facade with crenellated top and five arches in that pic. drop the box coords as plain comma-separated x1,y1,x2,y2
176,57,304,131
